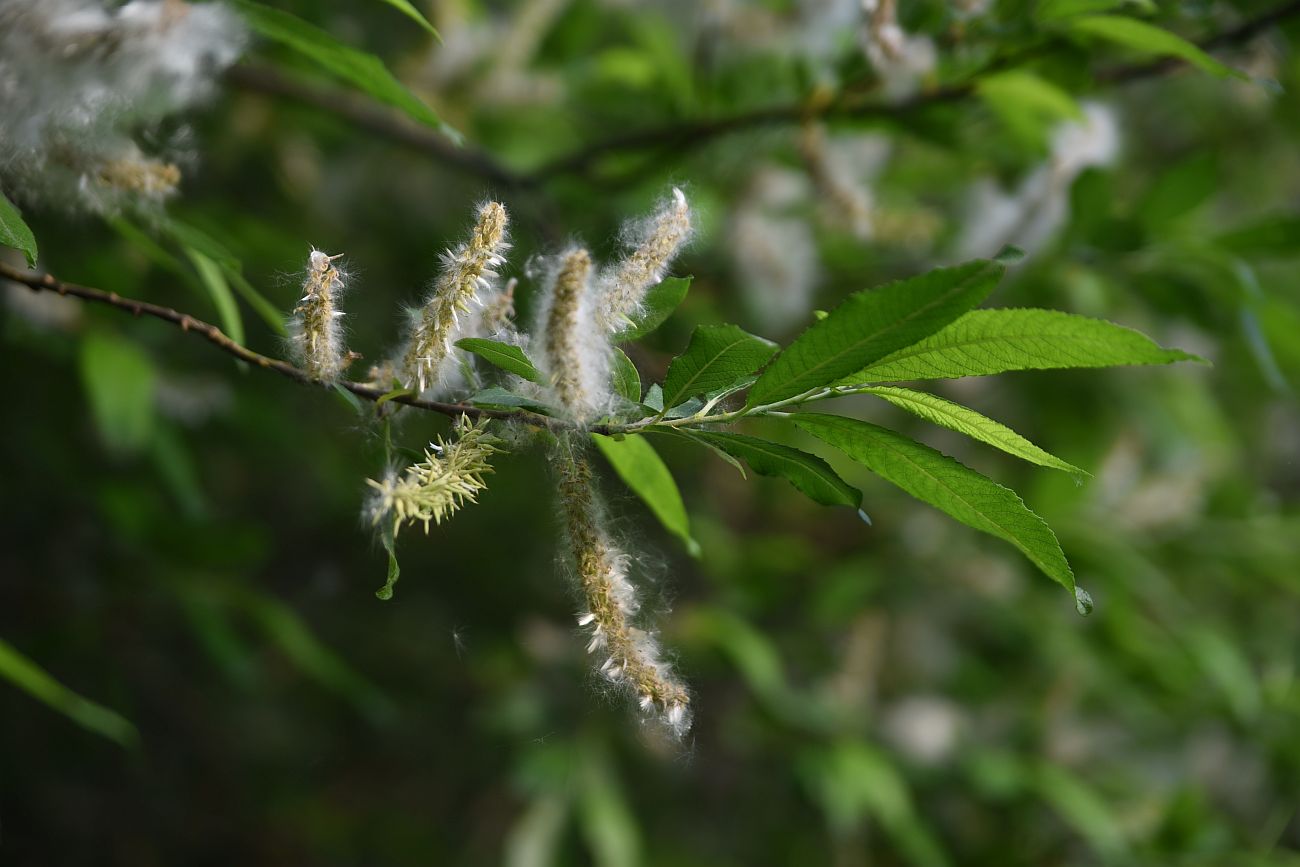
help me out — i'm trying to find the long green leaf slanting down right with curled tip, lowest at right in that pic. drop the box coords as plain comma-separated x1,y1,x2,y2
793,412,1074,593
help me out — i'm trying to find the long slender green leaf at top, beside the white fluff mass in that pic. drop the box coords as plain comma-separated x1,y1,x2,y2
231,0,459,138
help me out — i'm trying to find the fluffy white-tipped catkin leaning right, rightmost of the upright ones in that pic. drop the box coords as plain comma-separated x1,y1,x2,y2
597,187,690,334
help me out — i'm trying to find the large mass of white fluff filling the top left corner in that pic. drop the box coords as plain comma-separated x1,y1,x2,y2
0,0,246,212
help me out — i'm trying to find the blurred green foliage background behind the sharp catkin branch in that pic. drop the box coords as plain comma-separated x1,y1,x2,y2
0,0,1300,866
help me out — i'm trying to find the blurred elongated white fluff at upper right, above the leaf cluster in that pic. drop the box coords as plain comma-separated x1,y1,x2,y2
957,103,1121,259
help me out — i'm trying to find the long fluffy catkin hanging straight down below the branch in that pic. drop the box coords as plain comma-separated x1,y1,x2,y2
555,442,690,737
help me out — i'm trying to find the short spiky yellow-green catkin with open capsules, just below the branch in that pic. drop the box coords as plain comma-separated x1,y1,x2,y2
365,417,501,537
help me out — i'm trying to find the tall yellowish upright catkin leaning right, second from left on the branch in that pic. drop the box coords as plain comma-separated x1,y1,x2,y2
400,201,510,394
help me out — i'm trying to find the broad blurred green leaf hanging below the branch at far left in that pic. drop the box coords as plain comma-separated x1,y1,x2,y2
81,333,156,452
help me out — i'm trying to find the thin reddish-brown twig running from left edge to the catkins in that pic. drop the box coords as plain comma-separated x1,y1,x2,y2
0,261,573,429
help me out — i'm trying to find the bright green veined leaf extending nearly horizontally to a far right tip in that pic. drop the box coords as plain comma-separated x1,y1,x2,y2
840,308,1204,385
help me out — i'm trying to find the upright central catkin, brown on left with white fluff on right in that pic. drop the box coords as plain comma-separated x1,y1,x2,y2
538,248,610,422
